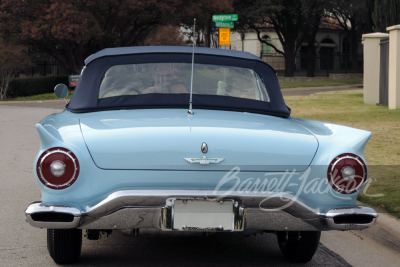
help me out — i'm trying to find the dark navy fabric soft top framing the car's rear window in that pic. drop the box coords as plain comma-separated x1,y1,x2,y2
67,46,290,118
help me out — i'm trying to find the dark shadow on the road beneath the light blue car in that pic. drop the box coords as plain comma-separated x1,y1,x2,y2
65,231,350,266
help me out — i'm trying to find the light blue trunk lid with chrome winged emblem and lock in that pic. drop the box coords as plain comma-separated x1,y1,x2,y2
80,109,318,172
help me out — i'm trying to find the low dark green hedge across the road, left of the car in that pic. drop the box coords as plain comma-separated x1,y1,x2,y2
8,76,68,98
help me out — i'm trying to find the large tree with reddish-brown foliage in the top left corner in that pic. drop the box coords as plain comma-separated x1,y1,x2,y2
0,0,102,73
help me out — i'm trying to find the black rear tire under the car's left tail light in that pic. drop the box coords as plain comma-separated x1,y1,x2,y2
47,229,82,264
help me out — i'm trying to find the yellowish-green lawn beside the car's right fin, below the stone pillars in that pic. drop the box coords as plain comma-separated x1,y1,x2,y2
285,90,400,218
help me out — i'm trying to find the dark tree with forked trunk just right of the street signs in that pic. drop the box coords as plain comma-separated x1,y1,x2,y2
234,0,305,77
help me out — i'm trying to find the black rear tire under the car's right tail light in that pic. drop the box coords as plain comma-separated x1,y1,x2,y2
277,231,321,263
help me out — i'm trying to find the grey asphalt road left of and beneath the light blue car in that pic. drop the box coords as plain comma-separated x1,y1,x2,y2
0,102,399,266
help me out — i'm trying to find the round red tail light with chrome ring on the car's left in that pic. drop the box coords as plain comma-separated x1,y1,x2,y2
36,147,79,189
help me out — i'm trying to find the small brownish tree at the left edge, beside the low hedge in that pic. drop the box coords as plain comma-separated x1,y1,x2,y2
0,40,30,99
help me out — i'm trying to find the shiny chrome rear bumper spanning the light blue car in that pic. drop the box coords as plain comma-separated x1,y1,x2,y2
25,190,378,231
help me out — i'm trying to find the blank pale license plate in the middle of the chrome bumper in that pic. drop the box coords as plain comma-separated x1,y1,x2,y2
172,199,235,231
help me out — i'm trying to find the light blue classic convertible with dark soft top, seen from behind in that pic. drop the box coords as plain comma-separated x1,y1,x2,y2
25,47,377,263
